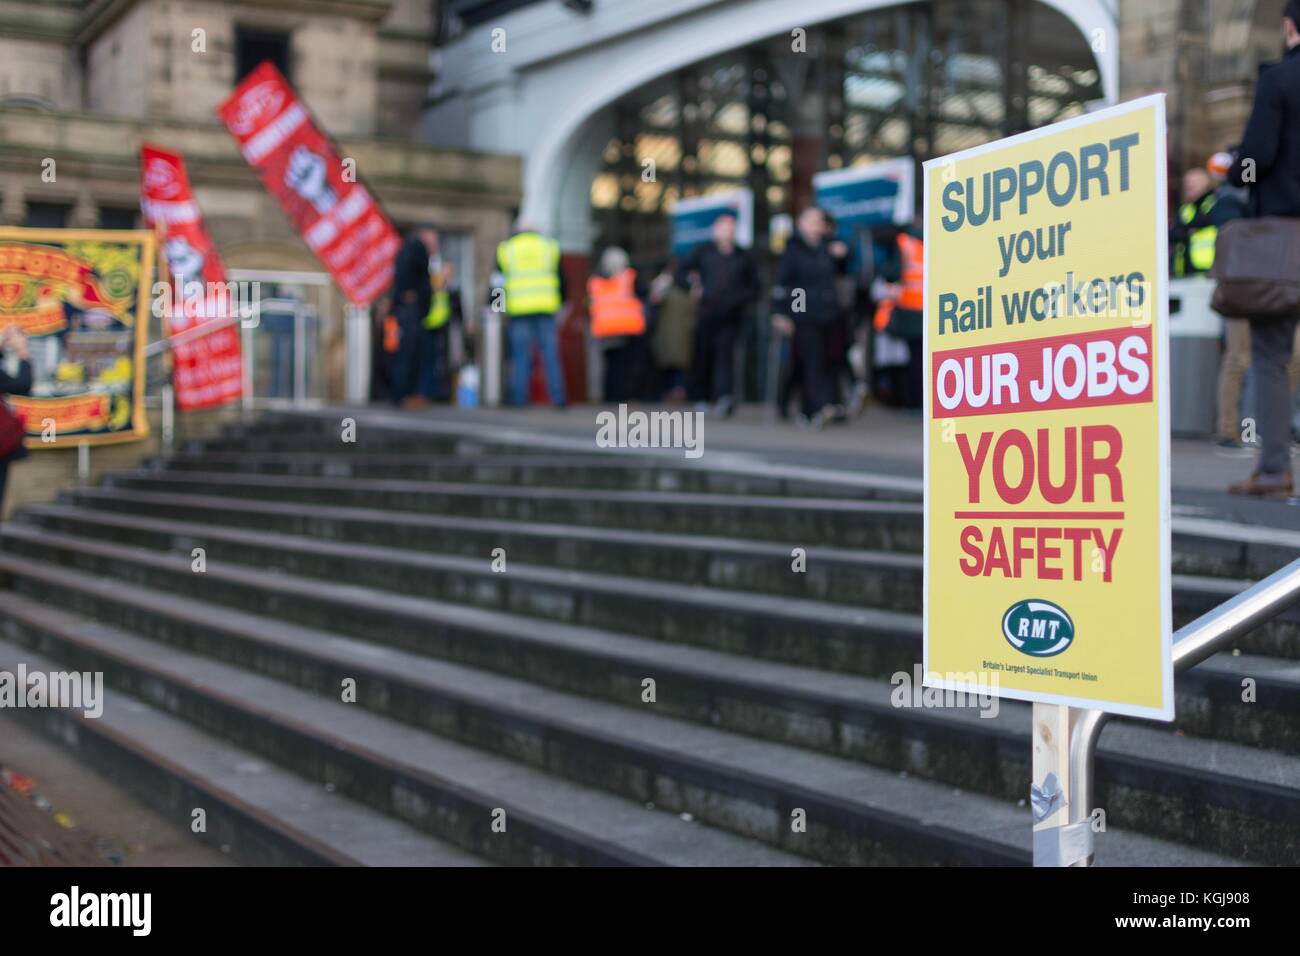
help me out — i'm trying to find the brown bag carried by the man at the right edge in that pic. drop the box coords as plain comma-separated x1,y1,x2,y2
1210,216,1300,319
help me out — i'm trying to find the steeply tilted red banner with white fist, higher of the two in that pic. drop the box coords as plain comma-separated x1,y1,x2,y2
217,61,402,306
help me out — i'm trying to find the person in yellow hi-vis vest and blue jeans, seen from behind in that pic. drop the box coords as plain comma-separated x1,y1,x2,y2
493,221,566,408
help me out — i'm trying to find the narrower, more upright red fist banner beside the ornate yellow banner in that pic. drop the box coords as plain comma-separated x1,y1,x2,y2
140,143,243,411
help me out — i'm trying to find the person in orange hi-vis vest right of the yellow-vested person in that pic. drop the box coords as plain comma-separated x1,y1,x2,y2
586,246,646,402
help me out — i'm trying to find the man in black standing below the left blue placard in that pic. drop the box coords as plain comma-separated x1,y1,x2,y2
677,213,758,418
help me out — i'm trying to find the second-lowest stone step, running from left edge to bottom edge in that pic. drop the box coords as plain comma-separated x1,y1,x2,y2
0,594,801,866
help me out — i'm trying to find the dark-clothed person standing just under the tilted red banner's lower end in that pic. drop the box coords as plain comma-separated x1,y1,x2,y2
389,222,438,408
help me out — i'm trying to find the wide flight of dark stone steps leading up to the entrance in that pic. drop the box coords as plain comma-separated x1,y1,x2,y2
0,410,1300,865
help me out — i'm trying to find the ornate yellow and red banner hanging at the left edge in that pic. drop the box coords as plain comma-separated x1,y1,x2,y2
0,228,155,449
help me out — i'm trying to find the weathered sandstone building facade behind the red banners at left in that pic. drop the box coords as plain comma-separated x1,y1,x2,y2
0,0,520,511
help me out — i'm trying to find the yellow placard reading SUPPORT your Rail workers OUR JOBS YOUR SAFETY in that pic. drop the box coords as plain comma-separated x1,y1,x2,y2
924,96,1174,721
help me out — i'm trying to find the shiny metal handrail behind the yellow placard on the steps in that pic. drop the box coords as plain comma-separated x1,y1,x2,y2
1070,558,1300,866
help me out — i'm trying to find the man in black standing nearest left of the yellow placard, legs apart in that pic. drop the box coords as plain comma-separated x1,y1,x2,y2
772,206,849,428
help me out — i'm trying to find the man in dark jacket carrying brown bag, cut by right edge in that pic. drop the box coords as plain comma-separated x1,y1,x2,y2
1229,0,1300,498
